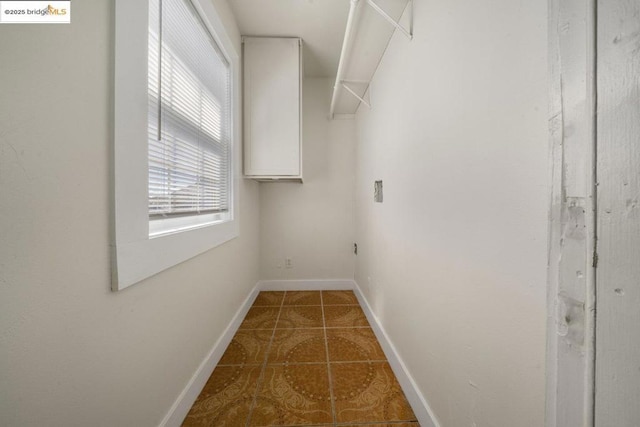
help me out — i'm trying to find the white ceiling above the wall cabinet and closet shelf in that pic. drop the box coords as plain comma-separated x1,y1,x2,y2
228,0,349,77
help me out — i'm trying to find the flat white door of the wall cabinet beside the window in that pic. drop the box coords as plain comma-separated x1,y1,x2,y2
244,37,301,176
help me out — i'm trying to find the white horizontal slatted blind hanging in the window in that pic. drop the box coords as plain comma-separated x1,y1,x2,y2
148,0,231,232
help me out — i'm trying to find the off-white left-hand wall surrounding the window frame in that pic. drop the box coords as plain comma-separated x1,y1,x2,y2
0,0,259,427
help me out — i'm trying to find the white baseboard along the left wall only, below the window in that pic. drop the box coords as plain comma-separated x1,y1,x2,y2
159,286,259,427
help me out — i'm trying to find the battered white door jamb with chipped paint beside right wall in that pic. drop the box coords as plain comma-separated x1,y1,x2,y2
546,0,597,427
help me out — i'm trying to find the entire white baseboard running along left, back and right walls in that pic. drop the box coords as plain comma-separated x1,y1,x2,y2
160,279,440,427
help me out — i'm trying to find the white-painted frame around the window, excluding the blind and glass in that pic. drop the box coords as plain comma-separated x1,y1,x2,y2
112,0,241,291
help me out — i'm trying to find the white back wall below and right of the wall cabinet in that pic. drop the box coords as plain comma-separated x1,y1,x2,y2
260,78,355,279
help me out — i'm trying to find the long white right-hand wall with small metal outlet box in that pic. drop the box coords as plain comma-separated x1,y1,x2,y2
356,0,549,427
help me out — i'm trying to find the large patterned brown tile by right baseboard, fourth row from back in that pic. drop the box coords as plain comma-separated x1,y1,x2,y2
331,362,416,423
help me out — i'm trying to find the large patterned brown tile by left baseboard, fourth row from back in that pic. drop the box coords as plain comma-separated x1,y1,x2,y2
182,366,262,427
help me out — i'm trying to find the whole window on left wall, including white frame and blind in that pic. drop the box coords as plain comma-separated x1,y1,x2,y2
113,0,239,290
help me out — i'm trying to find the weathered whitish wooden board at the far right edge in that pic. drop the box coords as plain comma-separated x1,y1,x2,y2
594,0,640,427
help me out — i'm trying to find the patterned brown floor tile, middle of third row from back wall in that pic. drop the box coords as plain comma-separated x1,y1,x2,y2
267,329,327,363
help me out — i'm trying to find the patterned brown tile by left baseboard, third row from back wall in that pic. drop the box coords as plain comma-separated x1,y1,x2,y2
218,329,273,366
